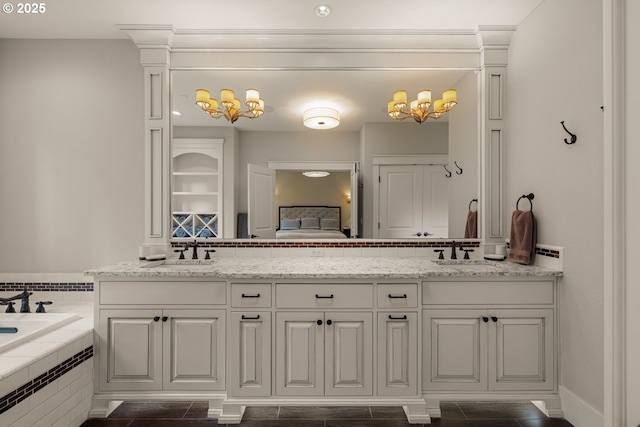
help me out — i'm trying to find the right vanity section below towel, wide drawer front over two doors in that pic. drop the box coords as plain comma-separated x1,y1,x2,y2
422,279,557,404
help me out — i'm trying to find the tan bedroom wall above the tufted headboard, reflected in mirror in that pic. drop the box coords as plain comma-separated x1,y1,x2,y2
276,171,351,227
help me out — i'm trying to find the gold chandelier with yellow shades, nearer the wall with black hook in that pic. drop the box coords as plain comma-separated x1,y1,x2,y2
387,89,457,123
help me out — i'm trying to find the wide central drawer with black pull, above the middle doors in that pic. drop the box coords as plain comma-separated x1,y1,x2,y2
276,283,373,309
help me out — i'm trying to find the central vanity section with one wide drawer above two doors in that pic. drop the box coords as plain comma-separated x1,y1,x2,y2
275,283,373,396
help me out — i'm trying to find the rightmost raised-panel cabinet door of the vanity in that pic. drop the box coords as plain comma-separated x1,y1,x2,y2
489,309,554,390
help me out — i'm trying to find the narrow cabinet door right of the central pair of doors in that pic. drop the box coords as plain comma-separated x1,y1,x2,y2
378,313,418,396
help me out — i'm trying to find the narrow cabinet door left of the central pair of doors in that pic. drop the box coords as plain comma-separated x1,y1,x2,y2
229,312,271,396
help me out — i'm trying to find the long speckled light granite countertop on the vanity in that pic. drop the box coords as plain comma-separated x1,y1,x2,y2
84,257,562,279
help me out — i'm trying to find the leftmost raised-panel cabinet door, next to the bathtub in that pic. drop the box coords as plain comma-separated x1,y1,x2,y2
98,310,162,390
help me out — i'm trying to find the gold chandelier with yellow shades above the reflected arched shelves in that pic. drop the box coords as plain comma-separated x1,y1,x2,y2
196,89,264,123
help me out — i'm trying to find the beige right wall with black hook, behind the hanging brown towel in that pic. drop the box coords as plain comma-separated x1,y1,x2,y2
505,0,604,421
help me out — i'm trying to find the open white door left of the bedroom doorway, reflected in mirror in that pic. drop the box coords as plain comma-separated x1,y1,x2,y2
247,164,278,239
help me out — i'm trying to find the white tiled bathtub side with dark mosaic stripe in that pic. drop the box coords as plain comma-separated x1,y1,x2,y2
0,324,93,427
